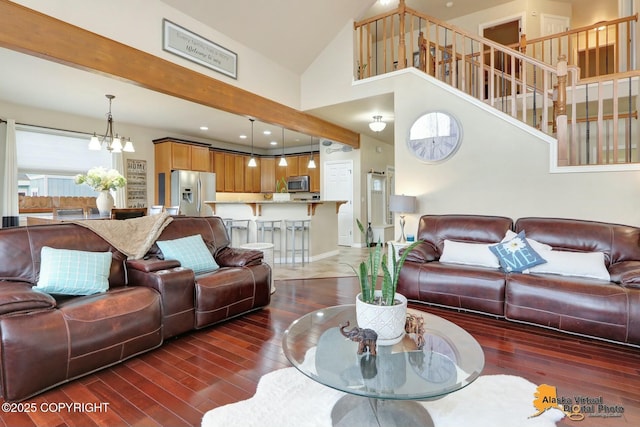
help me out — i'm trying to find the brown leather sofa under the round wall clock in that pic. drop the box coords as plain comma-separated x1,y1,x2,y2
398,215,640,346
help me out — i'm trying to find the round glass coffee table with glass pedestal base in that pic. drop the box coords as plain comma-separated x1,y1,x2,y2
282,305,484,427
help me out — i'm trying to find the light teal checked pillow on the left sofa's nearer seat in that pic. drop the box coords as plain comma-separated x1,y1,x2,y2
33,246,112,295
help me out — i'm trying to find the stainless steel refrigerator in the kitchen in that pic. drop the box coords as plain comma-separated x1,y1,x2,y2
171,171,216,216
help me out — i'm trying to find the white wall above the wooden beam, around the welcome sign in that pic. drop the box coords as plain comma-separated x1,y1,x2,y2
13,0,300,109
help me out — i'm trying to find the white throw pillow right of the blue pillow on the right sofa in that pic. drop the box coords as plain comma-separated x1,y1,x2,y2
525,250,611,281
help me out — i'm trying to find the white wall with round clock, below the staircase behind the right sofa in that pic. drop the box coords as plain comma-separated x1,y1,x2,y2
384,70,640,234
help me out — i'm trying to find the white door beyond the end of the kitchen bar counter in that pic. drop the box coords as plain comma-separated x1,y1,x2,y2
322,160,354,246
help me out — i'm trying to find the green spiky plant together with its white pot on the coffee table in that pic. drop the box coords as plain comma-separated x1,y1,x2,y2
351,220,420,345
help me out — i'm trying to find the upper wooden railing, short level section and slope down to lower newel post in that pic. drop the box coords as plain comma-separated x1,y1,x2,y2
354,0,577,142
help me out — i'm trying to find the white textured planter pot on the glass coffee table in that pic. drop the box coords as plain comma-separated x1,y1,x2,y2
356,290,407,345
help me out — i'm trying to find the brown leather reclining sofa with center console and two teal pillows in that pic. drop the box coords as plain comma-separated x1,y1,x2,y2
0,217,271,401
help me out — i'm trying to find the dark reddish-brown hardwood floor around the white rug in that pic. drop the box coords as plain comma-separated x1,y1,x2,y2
0,278,640,427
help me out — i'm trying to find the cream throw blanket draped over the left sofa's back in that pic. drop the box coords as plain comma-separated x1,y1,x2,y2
73,212,173,259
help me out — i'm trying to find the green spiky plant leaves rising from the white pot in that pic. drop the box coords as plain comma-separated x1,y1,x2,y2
351,219,420,305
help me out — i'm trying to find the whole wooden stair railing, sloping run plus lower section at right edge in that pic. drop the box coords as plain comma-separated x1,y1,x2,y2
354,0,640,165
